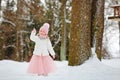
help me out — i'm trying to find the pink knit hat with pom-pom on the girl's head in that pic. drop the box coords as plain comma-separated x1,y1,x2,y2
39,23,50,38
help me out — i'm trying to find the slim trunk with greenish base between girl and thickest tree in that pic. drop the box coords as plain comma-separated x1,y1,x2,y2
60,0,67,60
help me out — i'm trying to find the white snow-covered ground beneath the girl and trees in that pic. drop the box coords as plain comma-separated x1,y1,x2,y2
0,57,120,80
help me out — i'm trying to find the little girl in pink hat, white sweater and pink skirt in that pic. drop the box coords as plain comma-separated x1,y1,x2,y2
28,23,56,76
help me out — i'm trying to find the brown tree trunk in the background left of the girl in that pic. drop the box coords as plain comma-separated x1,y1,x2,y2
16,0,25,61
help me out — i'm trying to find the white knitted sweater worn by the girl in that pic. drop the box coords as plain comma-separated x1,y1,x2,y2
30,31,55,56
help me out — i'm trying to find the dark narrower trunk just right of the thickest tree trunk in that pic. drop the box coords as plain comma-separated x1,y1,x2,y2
92,0,105,60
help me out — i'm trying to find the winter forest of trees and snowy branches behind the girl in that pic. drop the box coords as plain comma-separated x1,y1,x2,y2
0,0,120,65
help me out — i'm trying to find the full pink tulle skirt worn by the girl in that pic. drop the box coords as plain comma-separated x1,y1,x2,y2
27,55,56,75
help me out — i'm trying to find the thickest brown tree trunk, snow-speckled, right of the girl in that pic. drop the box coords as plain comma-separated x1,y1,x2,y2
69,0,91,66
